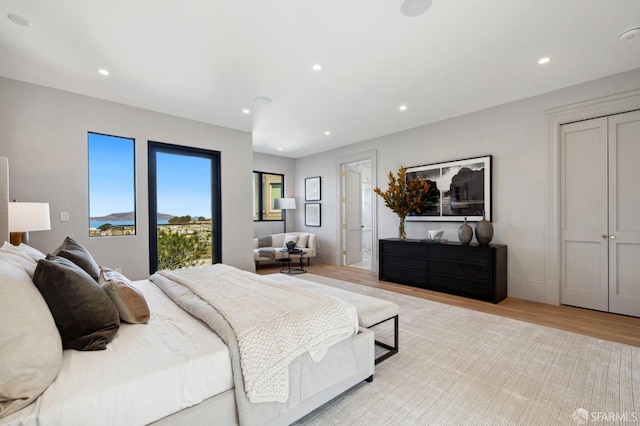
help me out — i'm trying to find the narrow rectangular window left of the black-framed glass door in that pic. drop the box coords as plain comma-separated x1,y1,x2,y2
87,132,136,237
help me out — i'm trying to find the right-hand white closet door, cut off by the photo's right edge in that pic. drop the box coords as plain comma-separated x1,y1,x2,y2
609,111,640,316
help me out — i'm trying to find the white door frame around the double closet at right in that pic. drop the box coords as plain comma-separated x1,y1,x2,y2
543,89,640,305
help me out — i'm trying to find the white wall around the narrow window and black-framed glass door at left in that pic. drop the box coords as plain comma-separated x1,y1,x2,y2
0,78,254,279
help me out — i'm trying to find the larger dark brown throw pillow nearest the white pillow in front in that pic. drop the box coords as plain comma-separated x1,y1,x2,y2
33,255,120,351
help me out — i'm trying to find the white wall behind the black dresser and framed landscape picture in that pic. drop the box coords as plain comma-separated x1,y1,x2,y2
296,69,640,301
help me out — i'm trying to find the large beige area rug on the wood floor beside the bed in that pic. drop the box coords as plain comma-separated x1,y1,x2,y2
296,274,640,425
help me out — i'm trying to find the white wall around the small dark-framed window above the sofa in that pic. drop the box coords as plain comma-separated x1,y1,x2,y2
253,152,296,237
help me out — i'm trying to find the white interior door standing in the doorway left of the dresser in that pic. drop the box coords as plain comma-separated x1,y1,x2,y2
344,166,362,265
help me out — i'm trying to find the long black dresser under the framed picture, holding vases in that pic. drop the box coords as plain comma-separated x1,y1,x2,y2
378,238,507,303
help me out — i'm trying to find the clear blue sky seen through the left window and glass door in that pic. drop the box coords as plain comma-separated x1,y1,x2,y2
89,133,211,218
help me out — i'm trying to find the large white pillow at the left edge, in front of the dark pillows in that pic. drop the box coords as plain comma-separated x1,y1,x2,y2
0,260,62,418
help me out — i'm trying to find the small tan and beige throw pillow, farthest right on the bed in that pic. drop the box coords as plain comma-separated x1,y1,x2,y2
98,267,151,324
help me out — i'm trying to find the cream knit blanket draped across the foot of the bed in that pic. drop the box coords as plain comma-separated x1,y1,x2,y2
158,264,354,402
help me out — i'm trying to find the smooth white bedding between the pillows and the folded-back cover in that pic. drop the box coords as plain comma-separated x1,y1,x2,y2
0,280,233,426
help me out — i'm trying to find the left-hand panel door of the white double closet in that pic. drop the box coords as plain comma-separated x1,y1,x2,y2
560,118,609,311
